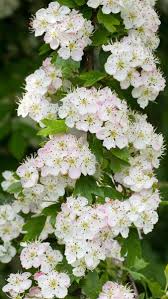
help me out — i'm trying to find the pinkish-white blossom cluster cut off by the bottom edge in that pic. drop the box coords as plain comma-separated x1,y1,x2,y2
98,281,135,299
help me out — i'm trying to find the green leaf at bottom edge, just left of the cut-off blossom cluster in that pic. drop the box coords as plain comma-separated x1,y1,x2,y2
82,270,101,299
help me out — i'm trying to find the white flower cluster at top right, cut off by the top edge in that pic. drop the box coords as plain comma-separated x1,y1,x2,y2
87,0,160,50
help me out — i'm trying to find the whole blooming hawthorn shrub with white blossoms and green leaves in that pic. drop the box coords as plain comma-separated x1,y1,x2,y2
0,0,167,299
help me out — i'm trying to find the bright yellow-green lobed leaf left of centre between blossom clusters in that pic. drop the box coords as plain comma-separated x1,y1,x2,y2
37,119,68,137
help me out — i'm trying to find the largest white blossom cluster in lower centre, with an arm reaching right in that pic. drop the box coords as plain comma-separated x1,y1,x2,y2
55,185,160,277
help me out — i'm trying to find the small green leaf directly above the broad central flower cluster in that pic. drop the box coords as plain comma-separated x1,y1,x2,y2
79,71,106,87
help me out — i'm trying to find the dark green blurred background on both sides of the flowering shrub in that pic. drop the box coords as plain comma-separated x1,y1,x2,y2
0,0,168,298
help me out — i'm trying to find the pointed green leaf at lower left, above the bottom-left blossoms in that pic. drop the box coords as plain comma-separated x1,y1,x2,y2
23,215,47,241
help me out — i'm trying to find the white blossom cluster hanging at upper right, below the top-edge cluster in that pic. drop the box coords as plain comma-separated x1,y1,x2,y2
103,35,165,108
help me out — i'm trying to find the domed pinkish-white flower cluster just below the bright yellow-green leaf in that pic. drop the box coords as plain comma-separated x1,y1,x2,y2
37,134,96,179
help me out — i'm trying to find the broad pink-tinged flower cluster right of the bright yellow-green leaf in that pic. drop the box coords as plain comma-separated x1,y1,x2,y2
58,87,129,149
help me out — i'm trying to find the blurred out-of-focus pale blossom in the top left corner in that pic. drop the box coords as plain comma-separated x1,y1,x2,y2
0,0,19,19
